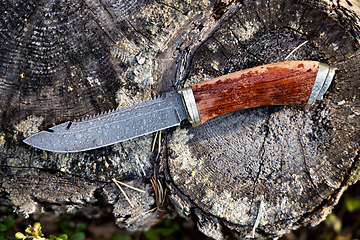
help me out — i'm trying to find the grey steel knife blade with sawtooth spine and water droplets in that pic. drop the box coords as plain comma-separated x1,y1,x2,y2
24,91,187,153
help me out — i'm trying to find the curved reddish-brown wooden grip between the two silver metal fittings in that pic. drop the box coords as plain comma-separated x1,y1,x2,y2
192,61,319,123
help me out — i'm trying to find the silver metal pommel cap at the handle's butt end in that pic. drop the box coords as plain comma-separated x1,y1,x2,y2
306,63,336,107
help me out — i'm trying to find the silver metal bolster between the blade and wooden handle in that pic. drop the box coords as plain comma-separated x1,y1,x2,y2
179,87,201,127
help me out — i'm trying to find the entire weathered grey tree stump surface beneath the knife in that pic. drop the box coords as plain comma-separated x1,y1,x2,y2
0,0,360,239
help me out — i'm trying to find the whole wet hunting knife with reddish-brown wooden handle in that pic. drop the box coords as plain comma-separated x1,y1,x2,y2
24,61,335,153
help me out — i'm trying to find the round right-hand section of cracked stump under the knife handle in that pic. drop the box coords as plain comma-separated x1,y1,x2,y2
169,1,360,238
